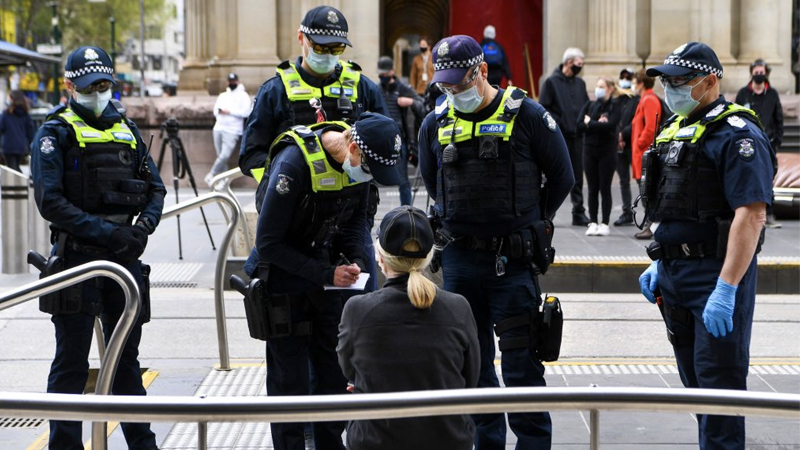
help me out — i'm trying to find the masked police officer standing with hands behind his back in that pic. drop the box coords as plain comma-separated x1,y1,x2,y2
419,35,575,450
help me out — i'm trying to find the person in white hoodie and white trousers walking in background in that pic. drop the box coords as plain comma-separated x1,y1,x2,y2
205,73,253,186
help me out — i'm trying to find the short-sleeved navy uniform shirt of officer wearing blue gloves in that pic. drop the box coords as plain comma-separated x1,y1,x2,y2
654,96,774,244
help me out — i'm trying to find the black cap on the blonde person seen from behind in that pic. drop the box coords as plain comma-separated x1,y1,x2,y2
378,205,434,258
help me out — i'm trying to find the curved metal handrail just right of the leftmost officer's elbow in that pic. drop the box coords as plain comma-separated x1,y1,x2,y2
161,192,242,370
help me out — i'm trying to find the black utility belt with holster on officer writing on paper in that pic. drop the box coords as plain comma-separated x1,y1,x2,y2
230,266,311,341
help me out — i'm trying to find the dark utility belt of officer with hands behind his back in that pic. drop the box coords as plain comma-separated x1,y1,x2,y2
452,219,556,276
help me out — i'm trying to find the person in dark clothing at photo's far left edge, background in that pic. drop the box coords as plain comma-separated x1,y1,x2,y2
0,91,34,172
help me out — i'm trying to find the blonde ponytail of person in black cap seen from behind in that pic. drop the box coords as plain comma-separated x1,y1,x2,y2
375,240,436,309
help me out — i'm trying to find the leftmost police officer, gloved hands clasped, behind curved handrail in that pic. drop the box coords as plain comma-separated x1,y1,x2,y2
31,47,166,450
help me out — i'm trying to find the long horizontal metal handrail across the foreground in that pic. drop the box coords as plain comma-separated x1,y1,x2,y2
0,387,800,450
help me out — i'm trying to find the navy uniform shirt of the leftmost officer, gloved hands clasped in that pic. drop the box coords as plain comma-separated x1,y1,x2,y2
31,100,167,246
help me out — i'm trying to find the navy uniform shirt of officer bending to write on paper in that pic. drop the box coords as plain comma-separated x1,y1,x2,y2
248,135,374,293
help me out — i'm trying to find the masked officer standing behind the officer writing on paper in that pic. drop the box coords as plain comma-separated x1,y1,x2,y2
239,6,389,290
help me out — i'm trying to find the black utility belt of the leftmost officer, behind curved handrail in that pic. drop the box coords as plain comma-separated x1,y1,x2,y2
28,250,151,323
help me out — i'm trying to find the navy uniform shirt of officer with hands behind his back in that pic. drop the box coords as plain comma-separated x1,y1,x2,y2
419,89,575,237
